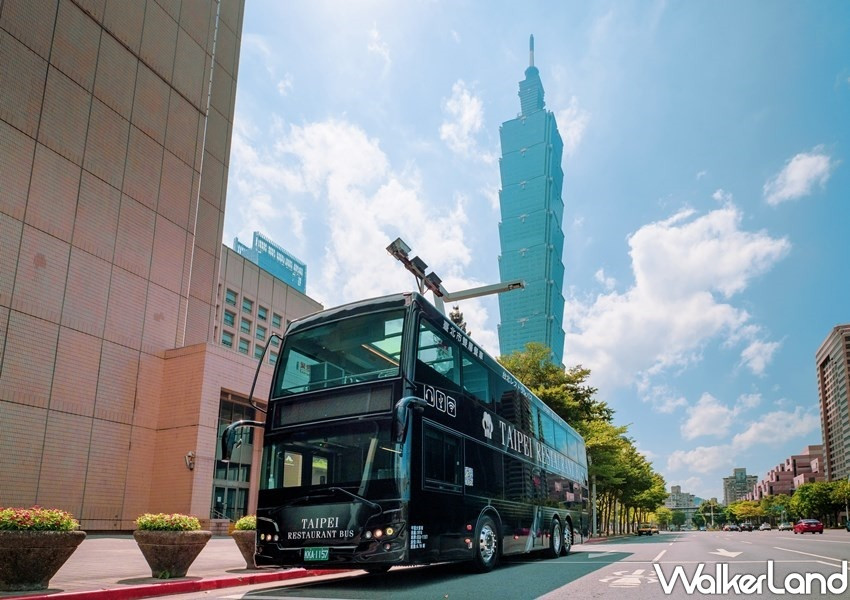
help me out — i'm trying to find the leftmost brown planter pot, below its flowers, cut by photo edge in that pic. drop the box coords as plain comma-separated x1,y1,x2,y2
0,531,86,592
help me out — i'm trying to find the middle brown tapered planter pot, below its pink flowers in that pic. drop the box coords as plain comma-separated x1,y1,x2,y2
133,530,212,579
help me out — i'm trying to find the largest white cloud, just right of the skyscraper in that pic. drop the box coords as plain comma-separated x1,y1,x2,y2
564,205,790,389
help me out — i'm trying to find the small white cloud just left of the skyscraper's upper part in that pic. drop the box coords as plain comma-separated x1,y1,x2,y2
440,79,495,163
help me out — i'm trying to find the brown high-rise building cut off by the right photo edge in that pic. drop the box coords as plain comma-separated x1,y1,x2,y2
815,324,850,481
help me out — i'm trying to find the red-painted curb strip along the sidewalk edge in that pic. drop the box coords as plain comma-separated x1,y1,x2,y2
2,569,342,600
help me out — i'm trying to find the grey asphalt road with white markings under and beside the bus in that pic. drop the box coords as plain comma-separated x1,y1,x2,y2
161,530,850,600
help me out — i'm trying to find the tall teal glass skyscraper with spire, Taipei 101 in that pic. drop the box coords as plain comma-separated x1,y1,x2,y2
499,36,564,365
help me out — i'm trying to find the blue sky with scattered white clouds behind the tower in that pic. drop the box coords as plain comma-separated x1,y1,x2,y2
224,0,850,500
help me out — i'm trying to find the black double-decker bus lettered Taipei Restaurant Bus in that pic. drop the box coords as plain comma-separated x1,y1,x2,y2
222,293,588,572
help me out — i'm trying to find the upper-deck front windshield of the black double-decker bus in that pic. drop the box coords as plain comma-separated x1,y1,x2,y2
274,310,404,397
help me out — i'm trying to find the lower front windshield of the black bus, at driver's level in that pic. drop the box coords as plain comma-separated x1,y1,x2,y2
260,419,398,496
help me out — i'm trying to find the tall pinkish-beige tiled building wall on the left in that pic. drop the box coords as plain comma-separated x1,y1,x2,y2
0,0,244,530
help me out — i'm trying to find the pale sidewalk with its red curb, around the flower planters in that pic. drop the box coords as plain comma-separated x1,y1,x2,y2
0,535,336,600
